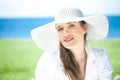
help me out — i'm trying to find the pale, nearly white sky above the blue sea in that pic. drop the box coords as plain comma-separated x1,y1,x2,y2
0,0,120,17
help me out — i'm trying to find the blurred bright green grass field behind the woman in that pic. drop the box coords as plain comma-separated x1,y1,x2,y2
0,39,120,80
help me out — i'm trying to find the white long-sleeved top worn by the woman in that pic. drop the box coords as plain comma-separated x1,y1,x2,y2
35,47,113,80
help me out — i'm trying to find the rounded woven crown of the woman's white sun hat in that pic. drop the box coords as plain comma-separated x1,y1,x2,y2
55,8,83,19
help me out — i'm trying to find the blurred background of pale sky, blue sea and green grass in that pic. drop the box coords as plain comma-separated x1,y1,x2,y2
0,0,120,80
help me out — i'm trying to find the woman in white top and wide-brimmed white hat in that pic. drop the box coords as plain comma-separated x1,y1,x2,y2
31,8,112,80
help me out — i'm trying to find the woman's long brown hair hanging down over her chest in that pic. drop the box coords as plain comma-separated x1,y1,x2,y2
60,21,86,80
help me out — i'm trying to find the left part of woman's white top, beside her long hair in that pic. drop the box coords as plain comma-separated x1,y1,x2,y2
35,49,68,80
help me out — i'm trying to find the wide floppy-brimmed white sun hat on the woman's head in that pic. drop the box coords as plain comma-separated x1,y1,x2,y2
31,8,108,50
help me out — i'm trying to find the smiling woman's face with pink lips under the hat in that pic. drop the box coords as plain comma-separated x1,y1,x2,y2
55,22,87,49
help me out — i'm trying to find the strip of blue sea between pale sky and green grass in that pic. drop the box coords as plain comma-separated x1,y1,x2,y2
0,15,120,39
